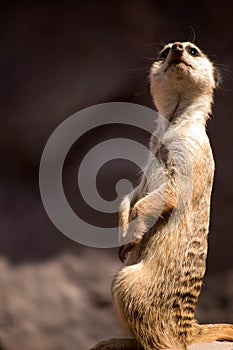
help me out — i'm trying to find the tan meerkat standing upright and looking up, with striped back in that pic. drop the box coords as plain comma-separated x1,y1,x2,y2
90,42,233,350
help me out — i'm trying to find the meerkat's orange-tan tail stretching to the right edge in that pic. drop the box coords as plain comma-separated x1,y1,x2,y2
192,324,233,343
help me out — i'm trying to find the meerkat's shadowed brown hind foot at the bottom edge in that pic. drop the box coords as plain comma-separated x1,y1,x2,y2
90,338,144,350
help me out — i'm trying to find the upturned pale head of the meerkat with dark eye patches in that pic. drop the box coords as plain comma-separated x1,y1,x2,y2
150,42,218,113
